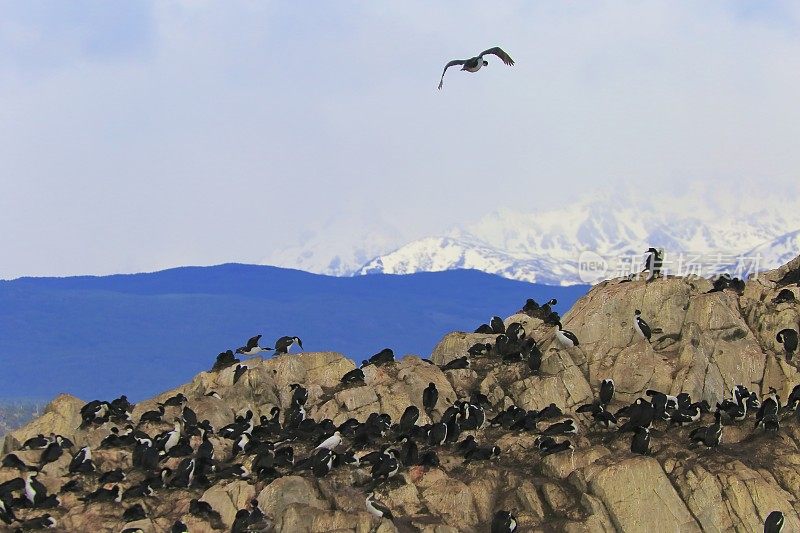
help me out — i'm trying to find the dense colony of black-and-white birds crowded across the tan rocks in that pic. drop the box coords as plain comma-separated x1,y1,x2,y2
0,255,800,533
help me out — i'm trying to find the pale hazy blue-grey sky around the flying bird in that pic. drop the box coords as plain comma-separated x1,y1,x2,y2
0,0,800,278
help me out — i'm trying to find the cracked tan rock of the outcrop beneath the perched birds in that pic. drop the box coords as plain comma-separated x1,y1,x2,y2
0,260,800,533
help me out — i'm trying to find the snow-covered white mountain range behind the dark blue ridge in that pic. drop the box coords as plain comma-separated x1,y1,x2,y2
266,200,800,285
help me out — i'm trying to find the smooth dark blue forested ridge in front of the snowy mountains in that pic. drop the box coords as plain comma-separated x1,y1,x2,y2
0,264,587,400
